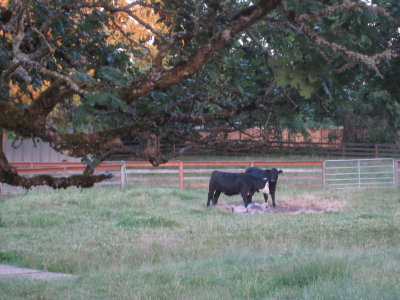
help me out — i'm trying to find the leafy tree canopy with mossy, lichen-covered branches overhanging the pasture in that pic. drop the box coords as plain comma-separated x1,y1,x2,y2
0,0,400,188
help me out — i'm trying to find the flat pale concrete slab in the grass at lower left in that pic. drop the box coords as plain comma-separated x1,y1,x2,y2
0,264,76,280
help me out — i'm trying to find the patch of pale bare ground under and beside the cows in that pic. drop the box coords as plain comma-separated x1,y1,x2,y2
213,198,344,214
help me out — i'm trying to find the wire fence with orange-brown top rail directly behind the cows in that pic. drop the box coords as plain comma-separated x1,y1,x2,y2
0,161,399,193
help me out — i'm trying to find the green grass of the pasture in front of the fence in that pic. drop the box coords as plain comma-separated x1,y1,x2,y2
0,187,400,300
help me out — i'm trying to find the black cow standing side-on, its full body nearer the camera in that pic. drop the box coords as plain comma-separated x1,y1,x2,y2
207,171,269,207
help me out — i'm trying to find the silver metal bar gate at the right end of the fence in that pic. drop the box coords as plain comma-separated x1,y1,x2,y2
323,158,398,189
